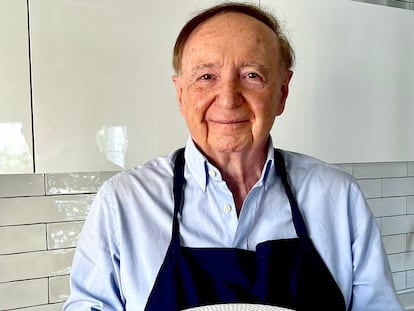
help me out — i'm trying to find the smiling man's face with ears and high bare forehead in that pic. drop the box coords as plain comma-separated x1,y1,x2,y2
173,13,292,157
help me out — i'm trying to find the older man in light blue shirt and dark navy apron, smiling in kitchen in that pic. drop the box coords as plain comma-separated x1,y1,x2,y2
64,3,402,311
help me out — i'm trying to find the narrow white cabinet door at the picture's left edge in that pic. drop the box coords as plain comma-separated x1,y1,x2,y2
0,0,33,174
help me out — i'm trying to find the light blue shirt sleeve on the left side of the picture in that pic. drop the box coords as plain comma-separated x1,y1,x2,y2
63,183,124,311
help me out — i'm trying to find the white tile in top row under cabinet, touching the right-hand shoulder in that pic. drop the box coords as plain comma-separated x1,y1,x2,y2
354,162,407,179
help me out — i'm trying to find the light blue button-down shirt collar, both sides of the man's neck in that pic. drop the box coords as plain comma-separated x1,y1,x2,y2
184,136,274,191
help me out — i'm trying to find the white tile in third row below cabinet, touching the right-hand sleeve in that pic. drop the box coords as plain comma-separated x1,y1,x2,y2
367,197,407,217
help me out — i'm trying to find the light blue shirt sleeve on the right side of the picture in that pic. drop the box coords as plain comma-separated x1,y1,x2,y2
349,184,404,311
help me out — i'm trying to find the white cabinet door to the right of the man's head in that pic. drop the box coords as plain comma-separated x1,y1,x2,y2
260,0,414,162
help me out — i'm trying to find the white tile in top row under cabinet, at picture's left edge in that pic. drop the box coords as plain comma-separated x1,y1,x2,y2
0,174,45,198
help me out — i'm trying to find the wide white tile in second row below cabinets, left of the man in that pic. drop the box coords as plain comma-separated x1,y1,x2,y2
0,194,94,226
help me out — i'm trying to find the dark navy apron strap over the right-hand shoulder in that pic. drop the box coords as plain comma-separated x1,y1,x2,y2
274,149,309,238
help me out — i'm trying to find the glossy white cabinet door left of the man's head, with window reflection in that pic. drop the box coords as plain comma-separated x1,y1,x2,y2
30,0,258,172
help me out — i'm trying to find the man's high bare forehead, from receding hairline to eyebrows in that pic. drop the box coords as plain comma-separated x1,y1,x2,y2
183,12,279,63
